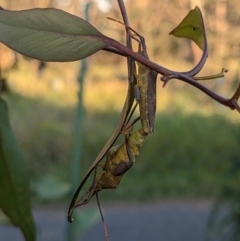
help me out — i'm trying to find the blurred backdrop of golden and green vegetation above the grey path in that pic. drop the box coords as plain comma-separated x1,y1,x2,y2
0,0,240,240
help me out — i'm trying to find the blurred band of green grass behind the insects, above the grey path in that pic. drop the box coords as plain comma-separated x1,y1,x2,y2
7,94,240,201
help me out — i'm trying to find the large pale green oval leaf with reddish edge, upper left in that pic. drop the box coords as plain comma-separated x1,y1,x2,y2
0,8,107,62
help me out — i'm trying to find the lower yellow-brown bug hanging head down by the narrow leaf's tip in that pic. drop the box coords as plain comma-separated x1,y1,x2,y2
68,128,148,219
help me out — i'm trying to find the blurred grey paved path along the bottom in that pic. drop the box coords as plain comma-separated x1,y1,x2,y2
0,202,217,241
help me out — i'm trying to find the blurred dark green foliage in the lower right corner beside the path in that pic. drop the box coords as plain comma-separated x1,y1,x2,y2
207,156,240,241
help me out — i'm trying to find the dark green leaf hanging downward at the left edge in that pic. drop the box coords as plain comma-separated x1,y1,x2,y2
0,98,36,241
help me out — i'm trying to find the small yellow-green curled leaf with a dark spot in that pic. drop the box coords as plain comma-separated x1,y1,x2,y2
169,7,206,50
